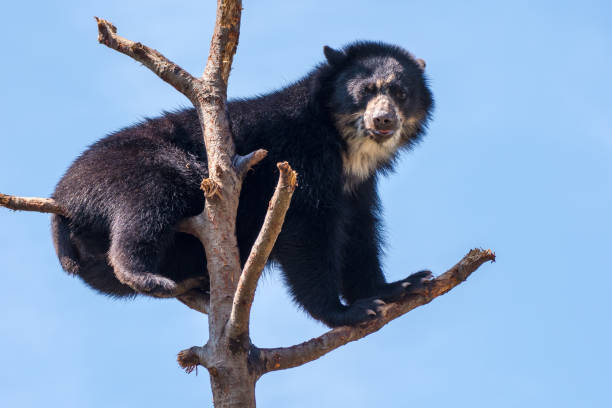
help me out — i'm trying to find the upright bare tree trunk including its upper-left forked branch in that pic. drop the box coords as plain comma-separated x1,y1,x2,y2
97,0,270,407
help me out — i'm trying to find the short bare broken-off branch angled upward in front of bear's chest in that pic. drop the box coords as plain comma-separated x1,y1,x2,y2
228,162,297,338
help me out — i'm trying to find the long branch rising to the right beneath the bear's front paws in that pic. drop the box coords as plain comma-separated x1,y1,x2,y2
258,249,495,375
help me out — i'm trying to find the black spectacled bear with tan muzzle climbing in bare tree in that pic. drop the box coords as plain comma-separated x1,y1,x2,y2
52,42,433,327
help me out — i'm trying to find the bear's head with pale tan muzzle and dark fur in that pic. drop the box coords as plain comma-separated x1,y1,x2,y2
325,44,432,190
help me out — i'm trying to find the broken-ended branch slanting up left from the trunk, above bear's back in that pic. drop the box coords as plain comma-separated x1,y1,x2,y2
94,17,198,100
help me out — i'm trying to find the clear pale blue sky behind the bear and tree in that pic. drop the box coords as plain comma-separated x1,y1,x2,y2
0,0,612,408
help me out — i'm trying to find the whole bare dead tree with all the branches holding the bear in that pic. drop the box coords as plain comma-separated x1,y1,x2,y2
0,0,495,408
